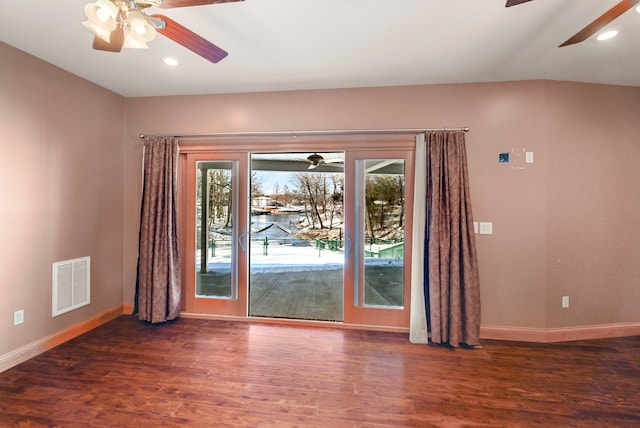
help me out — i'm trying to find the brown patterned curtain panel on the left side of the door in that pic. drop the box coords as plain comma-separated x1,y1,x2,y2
134,138,181,323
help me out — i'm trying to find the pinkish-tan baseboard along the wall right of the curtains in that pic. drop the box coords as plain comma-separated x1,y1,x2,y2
480,323,640,343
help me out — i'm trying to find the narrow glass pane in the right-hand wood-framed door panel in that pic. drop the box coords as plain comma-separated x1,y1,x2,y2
361,159,405,307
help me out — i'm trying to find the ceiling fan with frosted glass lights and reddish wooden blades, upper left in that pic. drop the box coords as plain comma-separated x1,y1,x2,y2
82,0,243,63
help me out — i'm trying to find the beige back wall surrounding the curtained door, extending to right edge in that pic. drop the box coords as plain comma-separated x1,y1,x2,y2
124,81,640,328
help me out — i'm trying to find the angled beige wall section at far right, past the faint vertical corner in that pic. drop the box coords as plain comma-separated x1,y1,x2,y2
545,84,640,326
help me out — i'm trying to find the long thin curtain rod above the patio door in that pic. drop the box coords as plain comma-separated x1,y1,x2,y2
140,126,469,138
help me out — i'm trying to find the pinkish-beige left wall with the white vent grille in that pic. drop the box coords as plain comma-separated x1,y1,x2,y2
0,43,125,356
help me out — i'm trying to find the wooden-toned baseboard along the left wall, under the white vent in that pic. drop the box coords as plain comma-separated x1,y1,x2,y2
0,305,131,373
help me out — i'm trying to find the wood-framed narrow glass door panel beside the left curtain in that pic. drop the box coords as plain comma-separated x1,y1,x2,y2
183,153,247,316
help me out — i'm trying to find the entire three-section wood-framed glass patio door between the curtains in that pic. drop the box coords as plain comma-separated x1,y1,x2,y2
181,141,413,327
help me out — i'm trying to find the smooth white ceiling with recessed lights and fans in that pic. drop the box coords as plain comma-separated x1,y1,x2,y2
0,0,640,97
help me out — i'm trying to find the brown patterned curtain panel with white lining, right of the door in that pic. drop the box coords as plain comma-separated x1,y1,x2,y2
424,131,480,347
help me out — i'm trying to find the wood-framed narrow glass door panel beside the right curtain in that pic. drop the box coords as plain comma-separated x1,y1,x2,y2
345,150,413,326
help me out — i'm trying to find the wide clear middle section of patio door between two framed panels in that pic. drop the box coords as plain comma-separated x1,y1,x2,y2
249,153,344,321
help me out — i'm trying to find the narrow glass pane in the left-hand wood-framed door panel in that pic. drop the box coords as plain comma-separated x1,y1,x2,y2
196,161,235,298
